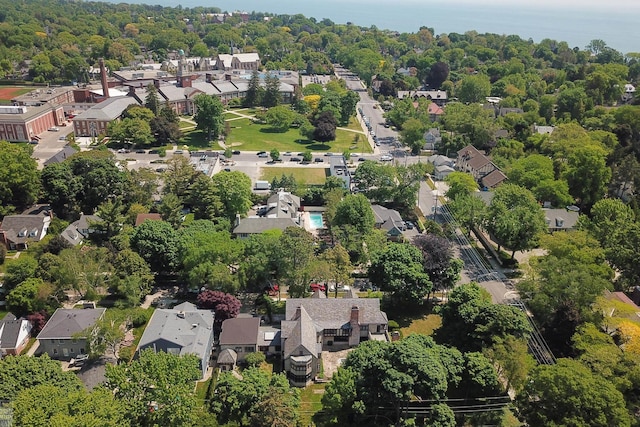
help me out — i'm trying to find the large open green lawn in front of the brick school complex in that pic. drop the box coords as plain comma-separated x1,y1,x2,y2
222,119,371,153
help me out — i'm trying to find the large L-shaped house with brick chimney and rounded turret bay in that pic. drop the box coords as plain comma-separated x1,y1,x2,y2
281,298,388,387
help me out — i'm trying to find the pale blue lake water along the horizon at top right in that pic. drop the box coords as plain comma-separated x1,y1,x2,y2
121,0,640,53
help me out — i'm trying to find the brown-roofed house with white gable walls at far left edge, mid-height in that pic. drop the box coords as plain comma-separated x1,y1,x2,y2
0,205,52,250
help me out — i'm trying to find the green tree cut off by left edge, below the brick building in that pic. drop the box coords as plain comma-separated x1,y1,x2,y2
0,141,40,217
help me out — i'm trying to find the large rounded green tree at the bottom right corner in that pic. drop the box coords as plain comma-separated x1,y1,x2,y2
516,359,631,427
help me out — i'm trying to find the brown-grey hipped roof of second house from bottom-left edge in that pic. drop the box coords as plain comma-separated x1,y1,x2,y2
38,308,106,340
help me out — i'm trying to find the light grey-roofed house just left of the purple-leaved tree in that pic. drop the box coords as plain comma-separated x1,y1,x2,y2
137,302,214,377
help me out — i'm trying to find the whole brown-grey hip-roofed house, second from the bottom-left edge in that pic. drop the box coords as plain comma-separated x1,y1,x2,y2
37,308,106,360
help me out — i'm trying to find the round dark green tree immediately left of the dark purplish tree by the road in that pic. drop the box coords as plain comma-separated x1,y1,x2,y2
369,243,432,305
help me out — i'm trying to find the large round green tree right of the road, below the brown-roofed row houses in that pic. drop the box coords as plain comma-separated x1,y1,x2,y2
485,184,547,259
